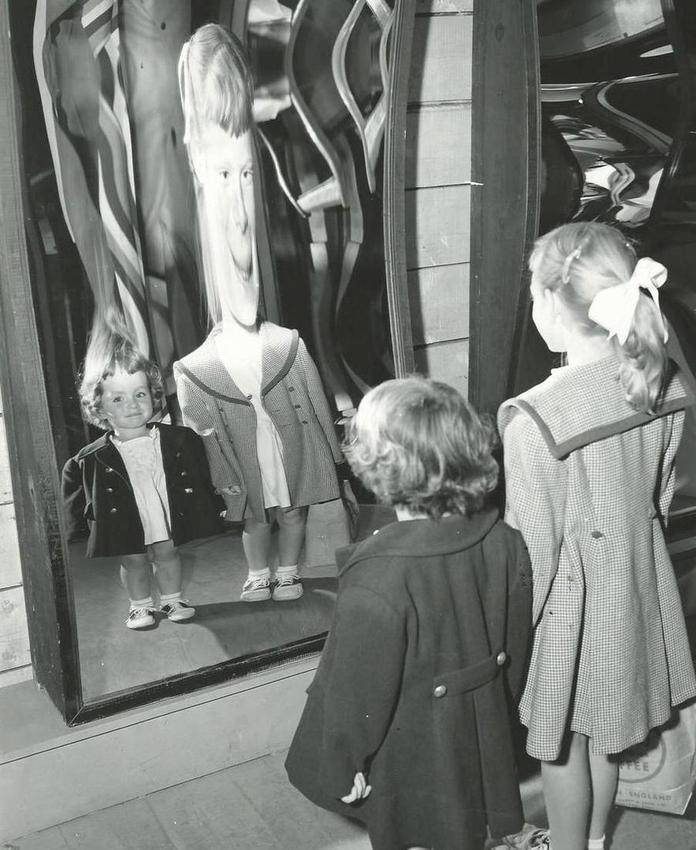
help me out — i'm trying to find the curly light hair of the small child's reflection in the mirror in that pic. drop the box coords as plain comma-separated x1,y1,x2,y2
79,331,164,431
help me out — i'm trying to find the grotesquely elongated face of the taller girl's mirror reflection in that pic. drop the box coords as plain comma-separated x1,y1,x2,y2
194,124,259,326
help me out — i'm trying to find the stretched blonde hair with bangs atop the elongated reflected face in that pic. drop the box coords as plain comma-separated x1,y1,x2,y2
179,24,254,144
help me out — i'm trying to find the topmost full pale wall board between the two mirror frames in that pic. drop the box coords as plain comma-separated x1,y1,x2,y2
408,14,472,103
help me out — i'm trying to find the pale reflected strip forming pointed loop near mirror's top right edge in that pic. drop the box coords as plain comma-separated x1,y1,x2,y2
331,0,394,193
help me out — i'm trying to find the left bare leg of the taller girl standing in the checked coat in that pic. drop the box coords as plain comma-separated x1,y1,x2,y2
541,732,592,850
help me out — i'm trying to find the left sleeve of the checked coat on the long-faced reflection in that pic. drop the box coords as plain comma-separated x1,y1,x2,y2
174,363,246,512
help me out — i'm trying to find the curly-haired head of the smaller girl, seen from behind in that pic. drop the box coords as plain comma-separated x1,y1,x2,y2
344,376,498,519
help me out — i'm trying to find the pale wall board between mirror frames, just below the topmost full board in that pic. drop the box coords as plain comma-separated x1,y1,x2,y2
406,103,471,189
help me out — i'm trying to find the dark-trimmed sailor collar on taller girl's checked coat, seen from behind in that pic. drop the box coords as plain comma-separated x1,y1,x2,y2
498,355,694,460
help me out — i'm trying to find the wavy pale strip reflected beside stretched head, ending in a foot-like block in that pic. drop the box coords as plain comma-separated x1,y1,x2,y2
285,0,345,213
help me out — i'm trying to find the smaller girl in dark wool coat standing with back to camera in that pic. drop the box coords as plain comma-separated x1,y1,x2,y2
286,377,531,850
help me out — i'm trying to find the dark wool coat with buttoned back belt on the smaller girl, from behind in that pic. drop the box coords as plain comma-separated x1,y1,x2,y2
286,511,532,850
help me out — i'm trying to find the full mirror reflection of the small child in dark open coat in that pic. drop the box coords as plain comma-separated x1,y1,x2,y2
62,337,220,629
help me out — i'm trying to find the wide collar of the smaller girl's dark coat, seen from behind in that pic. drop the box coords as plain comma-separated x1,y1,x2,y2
336,508,498,575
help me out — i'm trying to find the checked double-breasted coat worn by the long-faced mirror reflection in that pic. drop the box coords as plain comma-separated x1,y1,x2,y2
174,322,343,522
